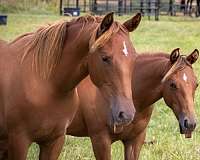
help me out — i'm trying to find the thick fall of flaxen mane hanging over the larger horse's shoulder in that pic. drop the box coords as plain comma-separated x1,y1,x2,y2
22,21,67,79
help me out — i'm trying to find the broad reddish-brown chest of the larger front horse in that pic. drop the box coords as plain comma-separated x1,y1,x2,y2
7,81,79,141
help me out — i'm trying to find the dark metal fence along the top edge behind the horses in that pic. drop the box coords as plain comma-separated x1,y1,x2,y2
61,0,199,20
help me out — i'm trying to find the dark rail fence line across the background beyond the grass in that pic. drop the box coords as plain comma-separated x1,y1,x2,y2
62,0,199,20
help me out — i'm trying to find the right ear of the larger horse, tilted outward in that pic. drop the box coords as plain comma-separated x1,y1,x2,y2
123,13,142,32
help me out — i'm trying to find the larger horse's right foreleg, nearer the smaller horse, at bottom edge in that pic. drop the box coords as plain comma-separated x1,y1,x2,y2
39,135,65,160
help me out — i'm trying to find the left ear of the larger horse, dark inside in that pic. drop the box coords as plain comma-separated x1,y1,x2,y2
96,12,114,39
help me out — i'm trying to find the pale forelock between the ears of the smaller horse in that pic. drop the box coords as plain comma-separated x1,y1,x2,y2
161,55,192,83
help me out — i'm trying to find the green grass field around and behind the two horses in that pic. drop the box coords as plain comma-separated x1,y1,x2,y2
0,14,200,160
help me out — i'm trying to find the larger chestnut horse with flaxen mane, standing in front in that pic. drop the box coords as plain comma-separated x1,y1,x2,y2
0,13,141,160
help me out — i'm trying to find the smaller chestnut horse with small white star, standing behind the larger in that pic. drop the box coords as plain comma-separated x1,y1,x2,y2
67,49,199,160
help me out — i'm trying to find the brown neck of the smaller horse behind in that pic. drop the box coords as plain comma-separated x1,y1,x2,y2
133,54,169,109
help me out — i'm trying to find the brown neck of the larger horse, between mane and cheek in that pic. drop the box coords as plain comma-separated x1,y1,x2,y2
53,21,96,92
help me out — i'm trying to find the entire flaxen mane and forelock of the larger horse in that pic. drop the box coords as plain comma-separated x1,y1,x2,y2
11,15,127,79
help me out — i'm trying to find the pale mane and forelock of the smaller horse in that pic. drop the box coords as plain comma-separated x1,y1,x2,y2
137,52,192,82
